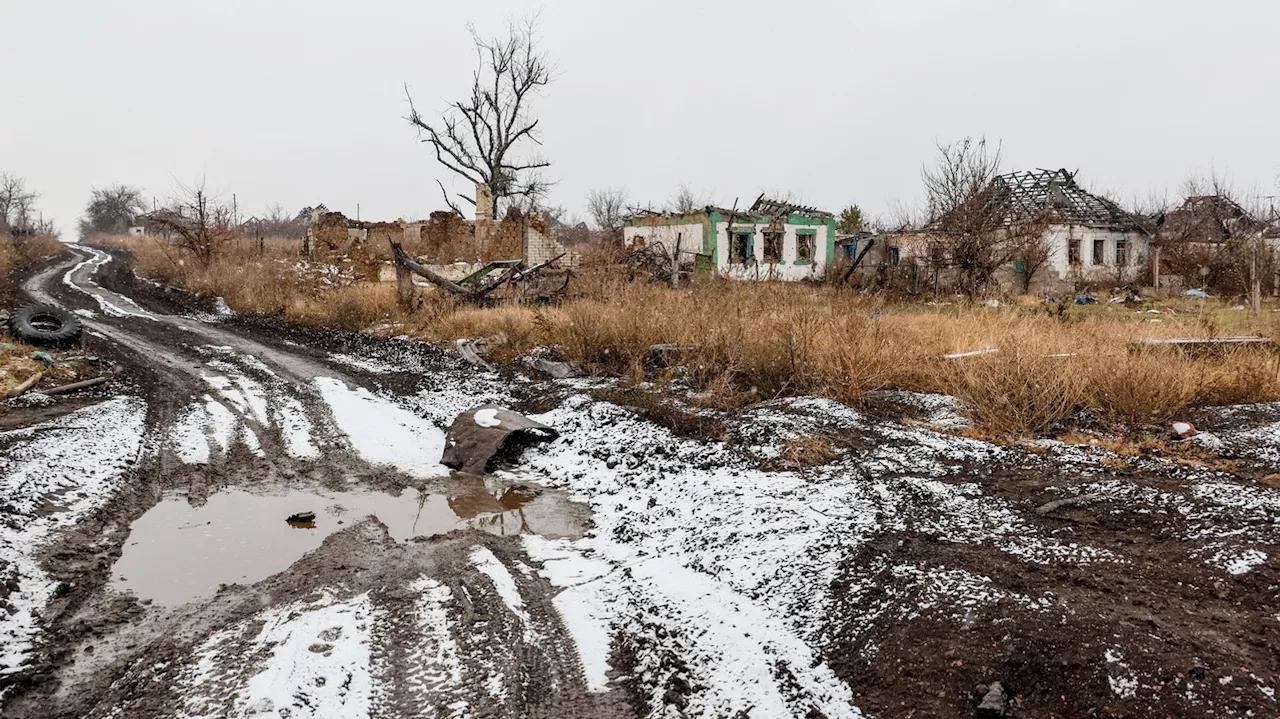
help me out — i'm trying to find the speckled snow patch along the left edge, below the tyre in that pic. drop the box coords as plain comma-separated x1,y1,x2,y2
0,397,146,674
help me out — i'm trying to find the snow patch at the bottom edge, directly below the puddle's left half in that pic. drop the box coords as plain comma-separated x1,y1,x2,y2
178,595,375,719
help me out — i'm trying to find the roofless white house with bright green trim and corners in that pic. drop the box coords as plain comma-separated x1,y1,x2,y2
622,197,836,280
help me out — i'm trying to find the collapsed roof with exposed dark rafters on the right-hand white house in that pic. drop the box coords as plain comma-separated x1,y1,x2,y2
962,169,1146,232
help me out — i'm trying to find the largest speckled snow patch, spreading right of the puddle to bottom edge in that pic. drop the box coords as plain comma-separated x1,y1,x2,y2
518,397,1115,716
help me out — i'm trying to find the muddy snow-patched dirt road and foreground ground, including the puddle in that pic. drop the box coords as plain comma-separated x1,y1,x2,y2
0,247,1280,719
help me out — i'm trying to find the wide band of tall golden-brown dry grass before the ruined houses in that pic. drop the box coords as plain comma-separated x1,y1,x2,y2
102,235,1280,435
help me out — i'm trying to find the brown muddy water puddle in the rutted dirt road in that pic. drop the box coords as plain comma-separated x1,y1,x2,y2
111,480,589,605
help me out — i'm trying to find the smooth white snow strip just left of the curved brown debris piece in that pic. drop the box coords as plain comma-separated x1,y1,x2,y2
312,377,449,477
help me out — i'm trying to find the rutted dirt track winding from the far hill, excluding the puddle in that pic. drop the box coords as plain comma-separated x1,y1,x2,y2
0,247,617,719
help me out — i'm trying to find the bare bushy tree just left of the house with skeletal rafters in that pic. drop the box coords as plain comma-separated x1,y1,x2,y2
920,137,1047,298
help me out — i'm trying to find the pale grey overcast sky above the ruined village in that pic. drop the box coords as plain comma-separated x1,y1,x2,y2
0,0,1280,235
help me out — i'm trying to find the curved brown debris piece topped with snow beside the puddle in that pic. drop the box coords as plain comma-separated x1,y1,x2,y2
440,404,559,475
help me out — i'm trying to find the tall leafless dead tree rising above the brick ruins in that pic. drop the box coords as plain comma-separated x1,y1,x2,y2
404,17,554,215
